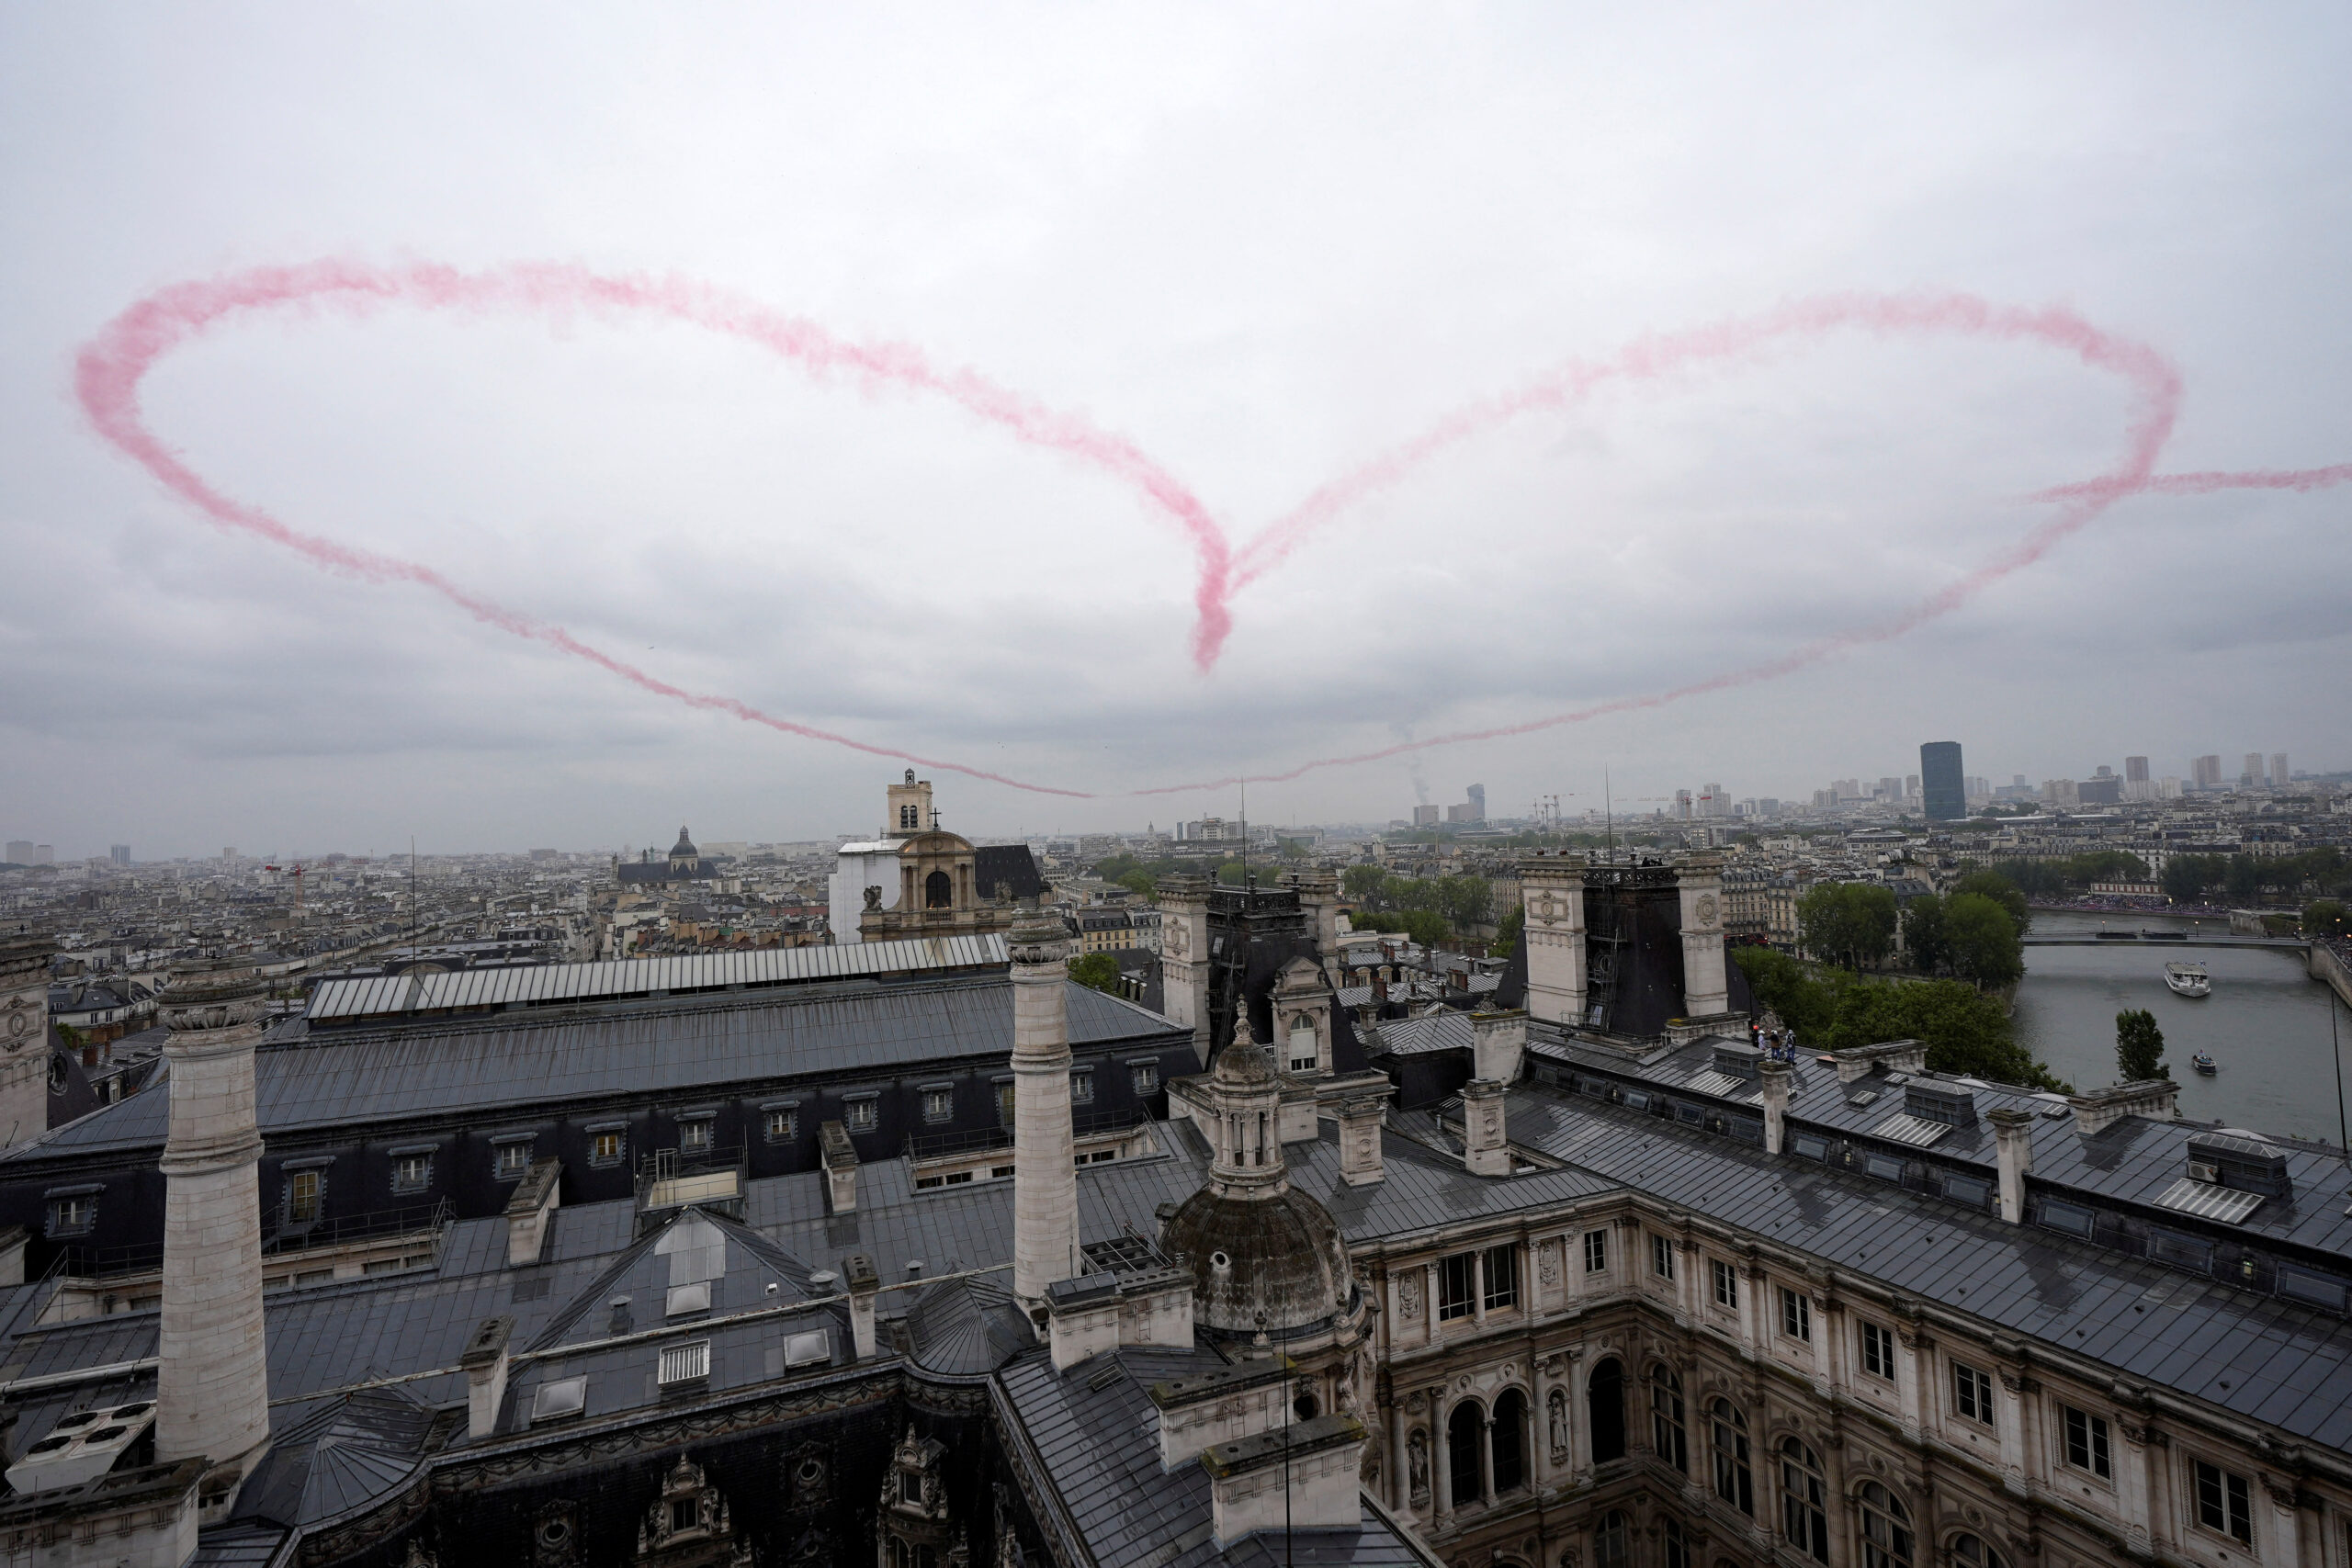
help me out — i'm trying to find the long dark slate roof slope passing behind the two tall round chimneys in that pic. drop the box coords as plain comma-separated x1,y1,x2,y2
0,974,1179,1159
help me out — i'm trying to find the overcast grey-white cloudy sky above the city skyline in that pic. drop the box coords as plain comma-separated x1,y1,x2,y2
0,0,2352,858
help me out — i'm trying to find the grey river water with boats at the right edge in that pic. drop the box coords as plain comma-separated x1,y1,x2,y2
2016,909,2352,1143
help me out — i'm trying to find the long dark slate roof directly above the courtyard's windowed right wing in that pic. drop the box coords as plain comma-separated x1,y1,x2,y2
1508,1090,2352,1448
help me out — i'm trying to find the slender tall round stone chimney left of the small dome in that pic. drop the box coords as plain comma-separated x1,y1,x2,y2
1009,912,1080,1312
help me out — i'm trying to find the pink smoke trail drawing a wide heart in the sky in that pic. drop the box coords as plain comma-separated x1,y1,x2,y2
75,261,2352,799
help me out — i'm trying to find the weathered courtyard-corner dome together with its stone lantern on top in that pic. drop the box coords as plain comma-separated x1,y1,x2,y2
1159,1042,1355,1340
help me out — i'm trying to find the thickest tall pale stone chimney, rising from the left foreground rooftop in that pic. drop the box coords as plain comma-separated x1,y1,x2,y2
155,964,270,1514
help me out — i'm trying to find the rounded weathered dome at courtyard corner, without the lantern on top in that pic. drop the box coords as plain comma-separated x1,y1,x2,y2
1159,1185,1355,1337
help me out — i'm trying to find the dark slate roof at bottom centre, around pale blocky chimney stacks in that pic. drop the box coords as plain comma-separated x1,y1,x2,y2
997,1349,1425,1568
